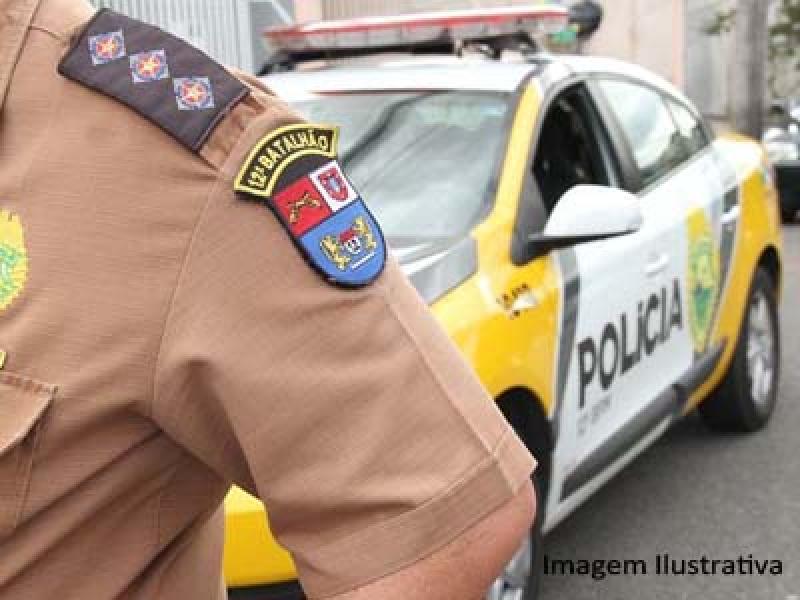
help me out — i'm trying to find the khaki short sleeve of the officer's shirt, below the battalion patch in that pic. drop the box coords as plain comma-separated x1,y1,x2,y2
152,120,534,597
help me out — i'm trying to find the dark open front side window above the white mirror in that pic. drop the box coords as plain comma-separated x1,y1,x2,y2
533,84,617,214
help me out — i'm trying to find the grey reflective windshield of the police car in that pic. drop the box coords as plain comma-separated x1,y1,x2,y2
293,91,509,246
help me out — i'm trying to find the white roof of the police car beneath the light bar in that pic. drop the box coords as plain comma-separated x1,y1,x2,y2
264,54,690,104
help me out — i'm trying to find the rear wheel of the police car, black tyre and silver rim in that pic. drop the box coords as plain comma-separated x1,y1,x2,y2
699,268,781,432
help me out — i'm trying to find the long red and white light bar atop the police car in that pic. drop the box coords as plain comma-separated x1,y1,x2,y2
264,3,569,53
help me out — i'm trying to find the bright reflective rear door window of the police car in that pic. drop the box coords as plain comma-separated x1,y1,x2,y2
599,80,689,187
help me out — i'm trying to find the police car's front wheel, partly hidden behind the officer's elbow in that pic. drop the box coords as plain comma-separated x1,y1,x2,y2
486,476,544,600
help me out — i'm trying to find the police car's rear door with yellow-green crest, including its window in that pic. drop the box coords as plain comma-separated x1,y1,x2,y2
598,79,739,395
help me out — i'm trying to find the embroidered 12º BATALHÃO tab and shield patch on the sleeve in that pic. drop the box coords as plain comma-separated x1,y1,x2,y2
234,124,386,287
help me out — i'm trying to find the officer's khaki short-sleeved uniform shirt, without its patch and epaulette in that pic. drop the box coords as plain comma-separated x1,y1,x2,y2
0,0,533,600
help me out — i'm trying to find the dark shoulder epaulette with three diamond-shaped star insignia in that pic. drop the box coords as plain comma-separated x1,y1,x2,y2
58,9,248,152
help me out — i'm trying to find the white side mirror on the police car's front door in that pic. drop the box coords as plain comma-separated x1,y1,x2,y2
529,185,642,255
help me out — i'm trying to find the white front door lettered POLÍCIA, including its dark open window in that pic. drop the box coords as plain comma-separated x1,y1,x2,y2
532,84,678,523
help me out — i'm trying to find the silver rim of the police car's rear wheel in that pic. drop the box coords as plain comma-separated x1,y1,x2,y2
747,291,775,412
